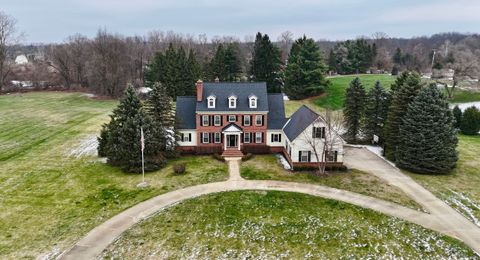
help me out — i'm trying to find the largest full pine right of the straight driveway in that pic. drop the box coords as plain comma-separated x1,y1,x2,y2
396,84,458,173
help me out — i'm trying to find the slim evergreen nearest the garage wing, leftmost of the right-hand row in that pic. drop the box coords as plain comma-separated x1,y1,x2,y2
343,77,365,143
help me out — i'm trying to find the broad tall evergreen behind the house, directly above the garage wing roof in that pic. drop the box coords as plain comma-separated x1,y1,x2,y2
285,36,329,99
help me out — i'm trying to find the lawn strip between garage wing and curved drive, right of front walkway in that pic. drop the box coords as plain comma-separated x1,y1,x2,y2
240,155,421,209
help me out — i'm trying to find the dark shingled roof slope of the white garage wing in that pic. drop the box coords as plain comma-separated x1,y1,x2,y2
283,105,319,141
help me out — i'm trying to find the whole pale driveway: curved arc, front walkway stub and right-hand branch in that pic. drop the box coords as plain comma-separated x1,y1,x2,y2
60,155,480,259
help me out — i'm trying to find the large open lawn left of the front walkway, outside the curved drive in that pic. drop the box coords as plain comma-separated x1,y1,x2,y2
0,92,228,259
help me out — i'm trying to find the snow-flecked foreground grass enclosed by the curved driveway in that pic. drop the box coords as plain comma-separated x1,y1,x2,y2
103,191,475,259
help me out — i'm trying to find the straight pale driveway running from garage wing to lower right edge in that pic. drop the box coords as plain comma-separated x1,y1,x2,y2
345,148,480,253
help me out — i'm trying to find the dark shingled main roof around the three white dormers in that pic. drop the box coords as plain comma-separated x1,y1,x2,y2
196,82,268,111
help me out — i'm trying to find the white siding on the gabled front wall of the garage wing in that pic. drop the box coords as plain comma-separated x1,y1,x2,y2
288,122,343,162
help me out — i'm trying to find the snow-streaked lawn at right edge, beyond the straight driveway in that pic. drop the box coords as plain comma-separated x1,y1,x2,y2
409,135,480,226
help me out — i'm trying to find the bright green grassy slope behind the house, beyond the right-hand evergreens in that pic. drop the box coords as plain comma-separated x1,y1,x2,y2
314,74,396,110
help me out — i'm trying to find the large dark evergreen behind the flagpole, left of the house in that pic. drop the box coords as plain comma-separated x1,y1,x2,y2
98,85,165,172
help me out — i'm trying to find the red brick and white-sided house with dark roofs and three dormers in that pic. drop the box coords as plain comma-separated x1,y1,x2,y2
176,80,343,167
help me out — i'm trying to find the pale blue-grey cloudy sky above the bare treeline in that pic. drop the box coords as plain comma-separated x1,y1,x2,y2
0,0,480,43
